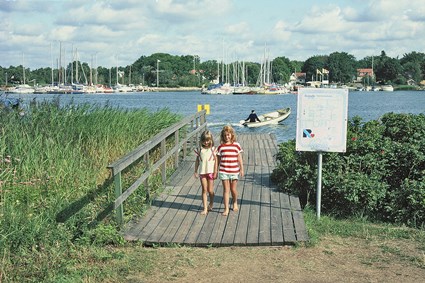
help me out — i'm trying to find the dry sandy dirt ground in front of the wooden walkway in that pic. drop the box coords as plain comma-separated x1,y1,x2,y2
126,237,425,283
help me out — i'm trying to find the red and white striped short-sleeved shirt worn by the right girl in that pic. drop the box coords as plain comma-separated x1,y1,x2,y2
217,142,243,174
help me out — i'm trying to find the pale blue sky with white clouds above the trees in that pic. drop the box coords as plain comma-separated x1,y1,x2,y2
0,0,425,70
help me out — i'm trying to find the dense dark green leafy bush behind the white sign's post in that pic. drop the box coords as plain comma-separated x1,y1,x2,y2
272,113,425,228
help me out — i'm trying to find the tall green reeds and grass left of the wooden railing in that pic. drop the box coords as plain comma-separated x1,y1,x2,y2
0,99,181,282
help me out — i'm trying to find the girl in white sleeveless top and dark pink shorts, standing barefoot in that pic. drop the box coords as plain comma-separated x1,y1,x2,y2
195,130,217,215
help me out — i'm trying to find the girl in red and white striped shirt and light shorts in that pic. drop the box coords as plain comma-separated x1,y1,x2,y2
217,125,244,216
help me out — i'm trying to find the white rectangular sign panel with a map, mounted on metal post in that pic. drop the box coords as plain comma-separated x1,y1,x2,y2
296,88,348,152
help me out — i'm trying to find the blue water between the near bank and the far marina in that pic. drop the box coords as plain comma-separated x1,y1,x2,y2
9,91,425,142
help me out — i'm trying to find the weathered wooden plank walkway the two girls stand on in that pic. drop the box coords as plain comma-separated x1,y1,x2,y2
124,134,308,246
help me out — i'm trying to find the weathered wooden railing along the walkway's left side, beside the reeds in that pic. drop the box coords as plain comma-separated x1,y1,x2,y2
108,110,207,225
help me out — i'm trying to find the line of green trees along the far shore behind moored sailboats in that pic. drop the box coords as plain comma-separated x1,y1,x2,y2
0,51,425,87
